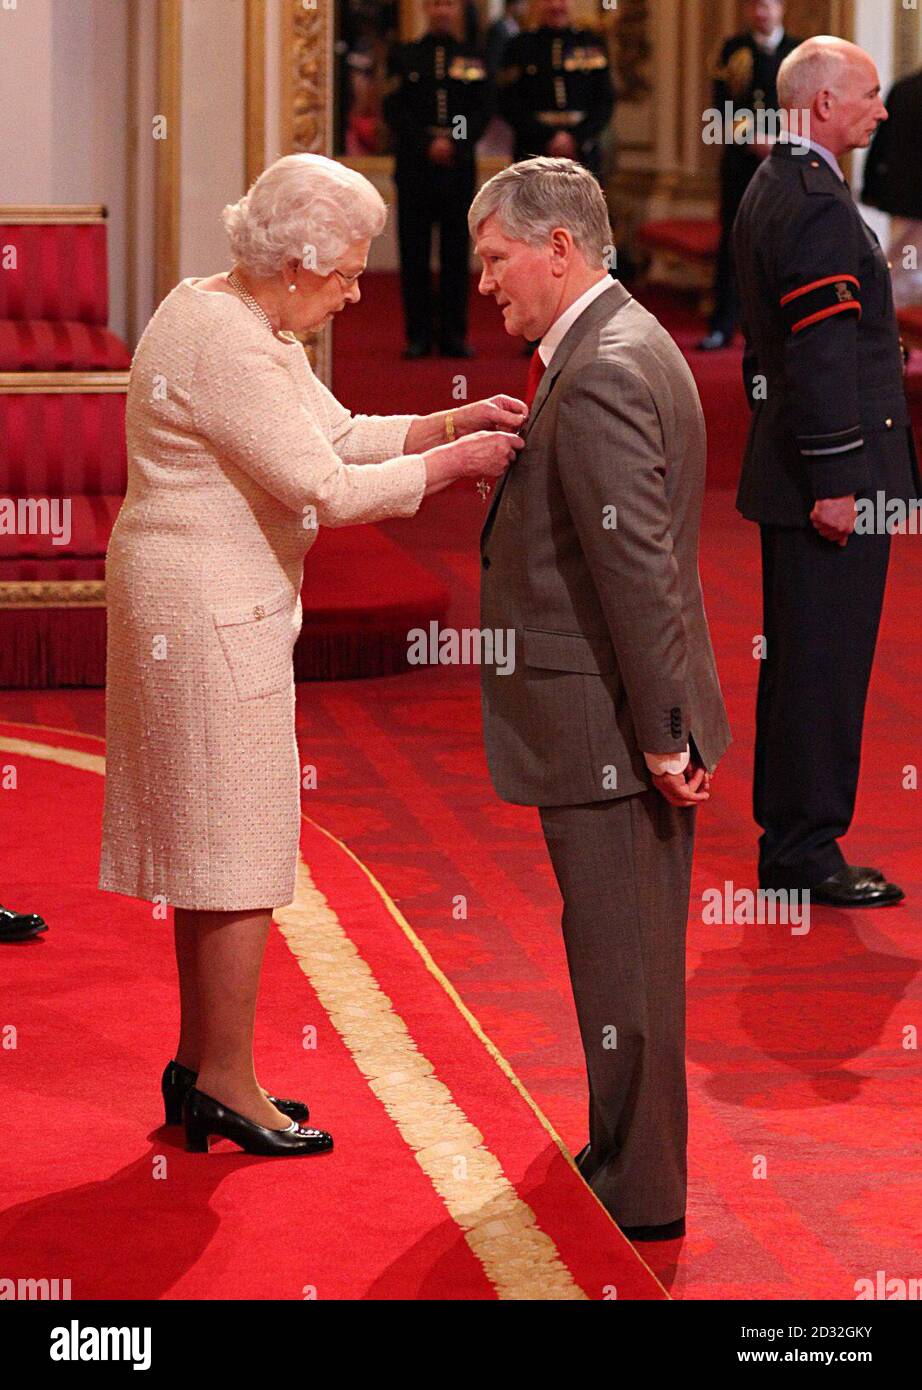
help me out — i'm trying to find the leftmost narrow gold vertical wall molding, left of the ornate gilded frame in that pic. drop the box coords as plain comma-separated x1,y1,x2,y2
154,0,182,303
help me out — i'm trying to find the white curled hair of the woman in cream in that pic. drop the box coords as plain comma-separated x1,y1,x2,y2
221,154,387,278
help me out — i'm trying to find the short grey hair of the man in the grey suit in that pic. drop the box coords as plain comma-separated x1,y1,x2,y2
467,154,612,265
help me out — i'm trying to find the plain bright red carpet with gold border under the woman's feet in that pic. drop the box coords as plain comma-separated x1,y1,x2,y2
0,724,665,1300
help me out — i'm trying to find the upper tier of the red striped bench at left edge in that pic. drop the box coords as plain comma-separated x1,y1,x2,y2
0,206,131,371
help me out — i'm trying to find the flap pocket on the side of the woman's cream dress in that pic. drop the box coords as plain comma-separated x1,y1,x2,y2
211,588,298,701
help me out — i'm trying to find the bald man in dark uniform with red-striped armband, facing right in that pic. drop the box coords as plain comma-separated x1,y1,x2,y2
733,38,921,906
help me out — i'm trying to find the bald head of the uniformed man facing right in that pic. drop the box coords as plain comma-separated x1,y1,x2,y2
777,35,887,154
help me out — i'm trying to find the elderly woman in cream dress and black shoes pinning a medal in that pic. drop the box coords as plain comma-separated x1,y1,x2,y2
100,154,526,1155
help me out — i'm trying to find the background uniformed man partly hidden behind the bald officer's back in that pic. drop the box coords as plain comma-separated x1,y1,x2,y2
698,0,801,352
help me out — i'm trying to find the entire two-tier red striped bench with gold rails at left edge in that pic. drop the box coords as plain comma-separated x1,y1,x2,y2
0,206,131,687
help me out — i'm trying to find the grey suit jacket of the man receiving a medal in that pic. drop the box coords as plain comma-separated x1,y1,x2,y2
481,281,730,806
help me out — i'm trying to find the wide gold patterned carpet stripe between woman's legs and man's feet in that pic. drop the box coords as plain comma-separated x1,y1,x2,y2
274,860,587,1301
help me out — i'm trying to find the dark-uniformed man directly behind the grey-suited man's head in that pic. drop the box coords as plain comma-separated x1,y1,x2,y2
498,0,615,175
